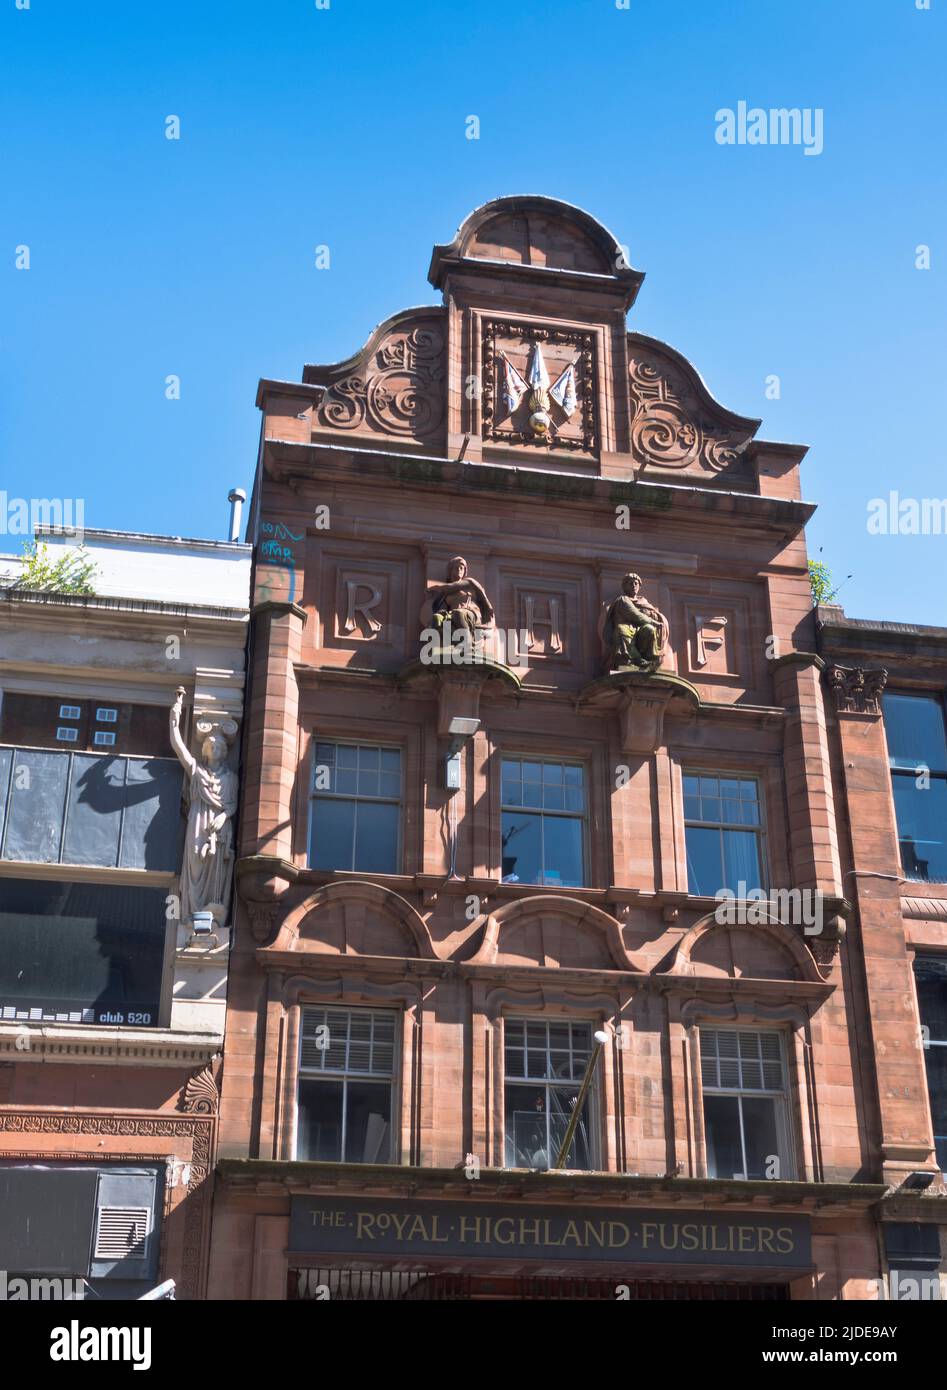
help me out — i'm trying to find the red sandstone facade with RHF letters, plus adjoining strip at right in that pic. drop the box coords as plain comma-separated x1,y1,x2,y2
209,197,947,1300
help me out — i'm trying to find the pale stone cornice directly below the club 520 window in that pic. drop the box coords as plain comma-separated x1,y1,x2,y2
0,1023,224,1068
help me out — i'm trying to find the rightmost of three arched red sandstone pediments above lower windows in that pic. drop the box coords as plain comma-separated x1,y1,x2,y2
669,916,823,984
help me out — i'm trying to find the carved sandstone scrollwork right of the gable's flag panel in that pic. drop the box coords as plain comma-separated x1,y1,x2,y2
629,350,752,473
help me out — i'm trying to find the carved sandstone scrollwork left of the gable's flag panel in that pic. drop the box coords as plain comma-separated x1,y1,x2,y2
317,328,444,436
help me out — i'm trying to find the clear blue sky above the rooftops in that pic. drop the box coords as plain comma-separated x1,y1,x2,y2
0,0,947,624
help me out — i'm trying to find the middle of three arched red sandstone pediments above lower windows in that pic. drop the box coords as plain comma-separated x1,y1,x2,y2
473,897,640,972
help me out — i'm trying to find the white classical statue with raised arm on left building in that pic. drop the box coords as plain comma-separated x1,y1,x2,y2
170,685,238,926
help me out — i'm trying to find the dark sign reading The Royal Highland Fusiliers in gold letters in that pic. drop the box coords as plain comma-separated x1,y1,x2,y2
289,1197,811,1269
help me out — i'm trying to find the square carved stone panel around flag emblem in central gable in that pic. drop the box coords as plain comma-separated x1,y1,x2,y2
480,318,598,453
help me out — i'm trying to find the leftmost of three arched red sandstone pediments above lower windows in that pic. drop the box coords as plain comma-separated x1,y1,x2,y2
264,881,435,959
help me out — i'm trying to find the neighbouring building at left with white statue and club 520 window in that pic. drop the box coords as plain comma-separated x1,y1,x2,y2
0,530,252,1297
